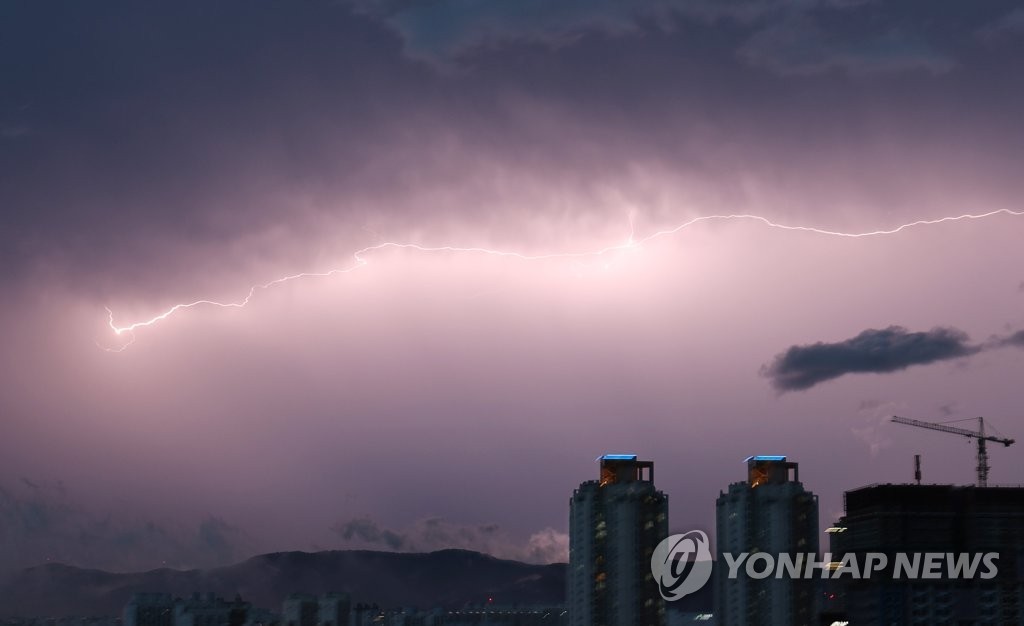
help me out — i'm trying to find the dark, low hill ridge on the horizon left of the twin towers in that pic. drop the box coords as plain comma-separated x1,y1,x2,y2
0,549,566,618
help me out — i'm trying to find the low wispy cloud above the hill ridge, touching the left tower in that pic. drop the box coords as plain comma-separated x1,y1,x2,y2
332,517,568,564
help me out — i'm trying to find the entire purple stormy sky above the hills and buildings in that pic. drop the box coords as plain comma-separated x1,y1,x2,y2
0,0,1024,570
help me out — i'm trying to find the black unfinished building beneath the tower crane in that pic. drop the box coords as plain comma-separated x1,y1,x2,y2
829,485,1024,625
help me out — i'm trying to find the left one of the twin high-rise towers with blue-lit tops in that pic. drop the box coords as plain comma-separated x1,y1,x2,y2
567,455,669,626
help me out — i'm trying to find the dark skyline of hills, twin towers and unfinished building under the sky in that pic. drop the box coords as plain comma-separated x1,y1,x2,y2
0,453,1024,626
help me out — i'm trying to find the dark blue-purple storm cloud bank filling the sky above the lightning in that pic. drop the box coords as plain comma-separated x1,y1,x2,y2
0,0,1020,293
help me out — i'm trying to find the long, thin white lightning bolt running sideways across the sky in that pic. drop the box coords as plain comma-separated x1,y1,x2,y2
100,209,1024,352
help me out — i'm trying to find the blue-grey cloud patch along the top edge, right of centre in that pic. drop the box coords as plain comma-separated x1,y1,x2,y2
355,0,991,75
